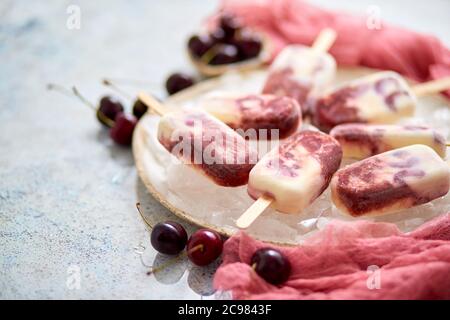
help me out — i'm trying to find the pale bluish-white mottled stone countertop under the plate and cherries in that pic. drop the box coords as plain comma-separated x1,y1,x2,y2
0,0,450,299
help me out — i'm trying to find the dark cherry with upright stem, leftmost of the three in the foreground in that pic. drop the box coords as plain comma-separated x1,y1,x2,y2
150,221,187,254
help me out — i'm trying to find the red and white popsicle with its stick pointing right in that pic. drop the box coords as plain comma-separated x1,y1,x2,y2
312,71,450,131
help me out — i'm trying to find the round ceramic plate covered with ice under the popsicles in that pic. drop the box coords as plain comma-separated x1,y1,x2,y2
133,68,450,245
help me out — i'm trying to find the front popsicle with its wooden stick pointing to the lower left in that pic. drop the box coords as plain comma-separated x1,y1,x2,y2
236,130,342,228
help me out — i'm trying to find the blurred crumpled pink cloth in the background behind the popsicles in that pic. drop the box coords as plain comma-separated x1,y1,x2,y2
213,0,450,96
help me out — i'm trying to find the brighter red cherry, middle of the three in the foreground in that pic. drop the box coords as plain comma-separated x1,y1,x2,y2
187,229,223,266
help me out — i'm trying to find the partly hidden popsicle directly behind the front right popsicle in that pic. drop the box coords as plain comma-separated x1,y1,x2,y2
330,123,447,159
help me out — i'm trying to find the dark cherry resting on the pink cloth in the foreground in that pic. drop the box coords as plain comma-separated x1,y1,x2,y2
251,248,291,285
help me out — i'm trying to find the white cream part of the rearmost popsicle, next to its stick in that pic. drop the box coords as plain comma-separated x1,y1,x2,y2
269,45,336,94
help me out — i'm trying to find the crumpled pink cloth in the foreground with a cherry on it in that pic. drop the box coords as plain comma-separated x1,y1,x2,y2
214,213,450,299
